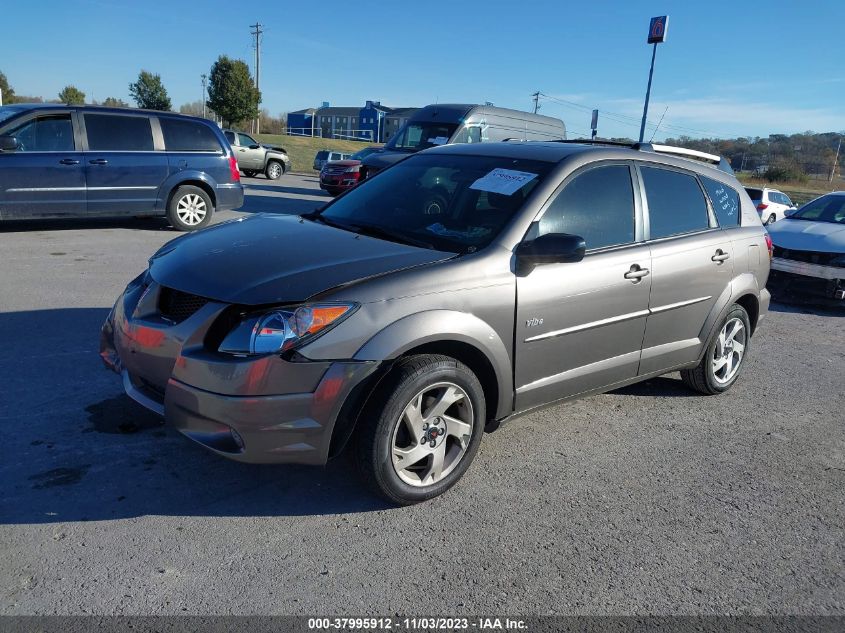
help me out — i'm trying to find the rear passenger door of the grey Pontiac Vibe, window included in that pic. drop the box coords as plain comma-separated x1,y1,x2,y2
639,164,733,375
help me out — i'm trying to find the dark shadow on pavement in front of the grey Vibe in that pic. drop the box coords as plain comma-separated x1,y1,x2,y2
0,308,389,524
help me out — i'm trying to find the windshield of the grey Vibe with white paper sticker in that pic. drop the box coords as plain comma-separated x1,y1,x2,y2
305,154,554,253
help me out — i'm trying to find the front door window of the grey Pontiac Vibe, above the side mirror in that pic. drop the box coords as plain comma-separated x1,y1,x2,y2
538,165,636,249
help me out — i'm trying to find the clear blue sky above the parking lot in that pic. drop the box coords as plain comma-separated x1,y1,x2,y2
0,0,845,140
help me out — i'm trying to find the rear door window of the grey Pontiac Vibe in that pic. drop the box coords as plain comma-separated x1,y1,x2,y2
640,167,710,240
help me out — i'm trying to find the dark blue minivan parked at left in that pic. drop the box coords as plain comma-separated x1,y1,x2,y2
0,103,244,231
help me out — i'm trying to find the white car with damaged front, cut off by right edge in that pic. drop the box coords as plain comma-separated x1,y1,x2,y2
767,191,845,305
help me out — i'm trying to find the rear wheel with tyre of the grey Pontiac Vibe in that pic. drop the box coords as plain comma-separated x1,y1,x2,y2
681,304,751,395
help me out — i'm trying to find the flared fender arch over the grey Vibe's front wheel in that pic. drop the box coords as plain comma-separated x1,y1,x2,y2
354,310,513,419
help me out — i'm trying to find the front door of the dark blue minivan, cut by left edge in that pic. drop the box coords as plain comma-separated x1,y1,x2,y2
0,110,85,220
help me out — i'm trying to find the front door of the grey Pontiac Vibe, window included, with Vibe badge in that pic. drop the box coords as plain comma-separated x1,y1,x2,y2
514,163,651,411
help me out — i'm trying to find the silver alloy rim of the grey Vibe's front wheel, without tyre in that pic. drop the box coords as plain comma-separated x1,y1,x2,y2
391,382,474,487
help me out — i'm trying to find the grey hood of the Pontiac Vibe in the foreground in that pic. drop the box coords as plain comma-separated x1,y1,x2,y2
150,214,454,305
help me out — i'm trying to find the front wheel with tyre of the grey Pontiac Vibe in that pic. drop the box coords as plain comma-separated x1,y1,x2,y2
355,354,486,505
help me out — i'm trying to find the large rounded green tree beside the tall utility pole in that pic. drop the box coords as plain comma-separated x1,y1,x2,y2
206,55,261,126
